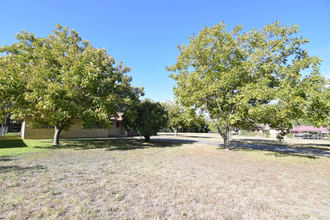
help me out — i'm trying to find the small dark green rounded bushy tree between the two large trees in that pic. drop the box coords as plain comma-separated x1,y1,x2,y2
123,99,167,141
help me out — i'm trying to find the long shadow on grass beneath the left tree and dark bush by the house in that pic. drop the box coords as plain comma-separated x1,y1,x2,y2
35,139,188,151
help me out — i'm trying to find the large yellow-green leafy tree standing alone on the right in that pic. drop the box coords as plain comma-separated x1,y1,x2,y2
166,22,320,150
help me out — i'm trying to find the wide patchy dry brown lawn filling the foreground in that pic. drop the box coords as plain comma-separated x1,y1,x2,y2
0,140,330,219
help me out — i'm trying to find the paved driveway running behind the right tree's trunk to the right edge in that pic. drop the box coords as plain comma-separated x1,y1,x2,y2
151,136,330,157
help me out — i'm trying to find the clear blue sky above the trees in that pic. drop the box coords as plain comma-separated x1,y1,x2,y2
0,0,330,101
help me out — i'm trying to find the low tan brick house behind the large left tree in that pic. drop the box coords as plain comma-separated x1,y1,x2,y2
20,114,138,139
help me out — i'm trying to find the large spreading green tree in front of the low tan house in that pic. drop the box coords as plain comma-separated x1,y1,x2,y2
0,24,143,145
